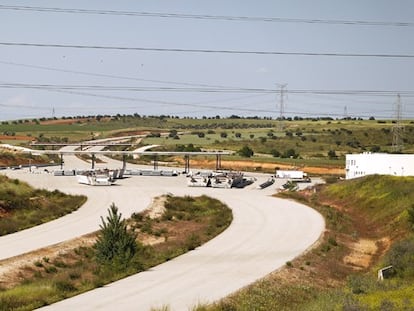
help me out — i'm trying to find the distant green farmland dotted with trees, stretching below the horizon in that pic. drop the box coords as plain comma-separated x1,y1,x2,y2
0,115,414,173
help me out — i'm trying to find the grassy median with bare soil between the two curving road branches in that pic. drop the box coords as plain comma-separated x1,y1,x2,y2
0,196,232,310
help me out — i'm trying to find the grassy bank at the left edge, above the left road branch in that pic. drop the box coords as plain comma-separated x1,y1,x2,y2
0,175,86,236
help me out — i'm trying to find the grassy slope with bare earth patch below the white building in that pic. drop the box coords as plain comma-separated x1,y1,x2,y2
200,176,414,311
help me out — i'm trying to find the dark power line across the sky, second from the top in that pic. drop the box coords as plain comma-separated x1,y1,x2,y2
0,42,414,59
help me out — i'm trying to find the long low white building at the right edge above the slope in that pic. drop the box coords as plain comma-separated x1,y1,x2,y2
345,152,414,179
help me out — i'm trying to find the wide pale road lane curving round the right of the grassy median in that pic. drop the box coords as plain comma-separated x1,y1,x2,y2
40,189,324,310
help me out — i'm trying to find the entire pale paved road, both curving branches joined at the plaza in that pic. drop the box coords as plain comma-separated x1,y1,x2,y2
0,150,324,311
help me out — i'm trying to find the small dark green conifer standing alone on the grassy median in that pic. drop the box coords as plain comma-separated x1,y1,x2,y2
94,203,137,266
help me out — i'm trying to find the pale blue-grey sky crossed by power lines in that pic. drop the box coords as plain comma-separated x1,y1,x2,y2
0,0,414,120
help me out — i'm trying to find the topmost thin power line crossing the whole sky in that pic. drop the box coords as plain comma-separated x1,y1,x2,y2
0,5,414,27
